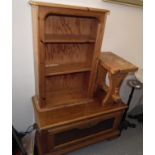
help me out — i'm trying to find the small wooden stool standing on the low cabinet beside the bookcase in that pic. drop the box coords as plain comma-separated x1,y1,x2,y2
97,52,138,106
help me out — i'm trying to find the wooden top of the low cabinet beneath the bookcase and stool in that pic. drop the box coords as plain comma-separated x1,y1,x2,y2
33,97,127,129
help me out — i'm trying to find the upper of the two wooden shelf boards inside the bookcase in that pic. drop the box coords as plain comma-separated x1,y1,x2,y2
43,34,95,43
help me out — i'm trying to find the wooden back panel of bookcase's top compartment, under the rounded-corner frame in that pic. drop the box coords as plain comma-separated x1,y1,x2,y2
45,14,97,37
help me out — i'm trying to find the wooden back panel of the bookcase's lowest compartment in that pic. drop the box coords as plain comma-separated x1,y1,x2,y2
46,72,90,92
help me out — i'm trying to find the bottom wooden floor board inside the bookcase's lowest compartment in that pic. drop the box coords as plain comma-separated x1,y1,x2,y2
45,89,90,109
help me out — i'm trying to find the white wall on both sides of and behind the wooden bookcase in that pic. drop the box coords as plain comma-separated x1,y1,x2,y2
13,0,143,130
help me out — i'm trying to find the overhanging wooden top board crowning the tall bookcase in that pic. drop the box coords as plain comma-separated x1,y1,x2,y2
29,0,109,13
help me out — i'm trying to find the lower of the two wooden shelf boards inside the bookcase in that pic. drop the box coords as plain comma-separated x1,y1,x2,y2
46,64,91,76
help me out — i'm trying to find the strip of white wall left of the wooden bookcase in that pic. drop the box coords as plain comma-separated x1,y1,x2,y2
12,0,34,130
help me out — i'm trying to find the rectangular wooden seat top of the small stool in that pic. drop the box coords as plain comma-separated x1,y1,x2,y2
100,52,138,73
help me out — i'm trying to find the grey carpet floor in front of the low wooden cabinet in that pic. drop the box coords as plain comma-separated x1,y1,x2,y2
67,120,143,155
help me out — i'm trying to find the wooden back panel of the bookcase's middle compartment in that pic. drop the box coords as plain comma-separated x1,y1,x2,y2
45,43,94,66
